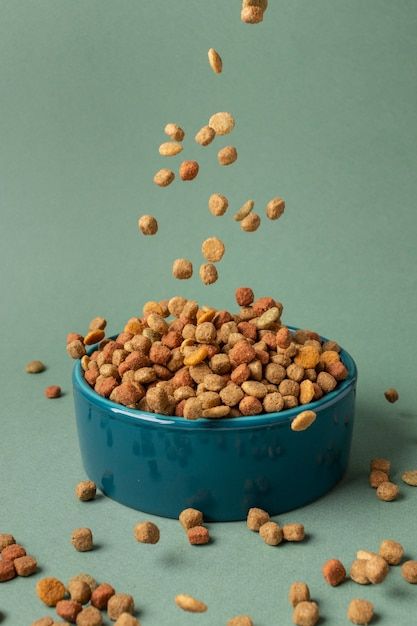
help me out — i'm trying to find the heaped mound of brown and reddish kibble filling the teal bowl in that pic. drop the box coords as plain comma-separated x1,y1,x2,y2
67,287,348,419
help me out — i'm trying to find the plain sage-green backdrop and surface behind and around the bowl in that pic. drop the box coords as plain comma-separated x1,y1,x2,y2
0,0,417,626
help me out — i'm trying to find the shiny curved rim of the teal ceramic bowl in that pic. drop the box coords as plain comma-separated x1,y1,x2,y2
72,326,358,431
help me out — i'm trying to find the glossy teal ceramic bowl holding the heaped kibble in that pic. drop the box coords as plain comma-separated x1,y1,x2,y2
73,330,357,521
